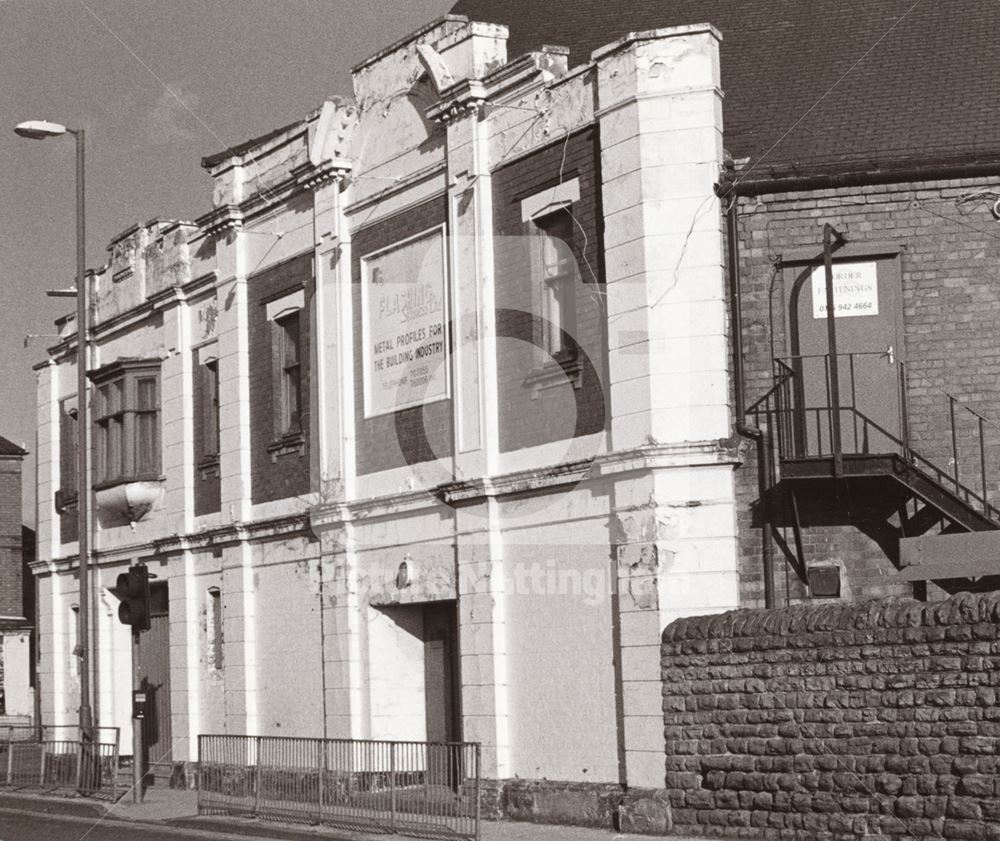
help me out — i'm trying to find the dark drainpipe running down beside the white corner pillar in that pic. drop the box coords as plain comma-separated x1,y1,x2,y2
717,179,775,608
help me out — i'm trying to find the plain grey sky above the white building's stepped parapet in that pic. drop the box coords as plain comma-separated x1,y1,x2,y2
0,0,452,525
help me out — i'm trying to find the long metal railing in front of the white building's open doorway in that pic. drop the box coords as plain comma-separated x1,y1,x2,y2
198,735,480,841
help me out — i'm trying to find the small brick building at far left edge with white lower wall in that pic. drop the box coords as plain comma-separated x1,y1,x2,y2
0,438,35,724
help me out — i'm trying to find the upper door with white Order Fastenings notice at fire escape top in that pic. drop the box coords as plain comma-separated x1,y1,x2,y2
786,255,904,455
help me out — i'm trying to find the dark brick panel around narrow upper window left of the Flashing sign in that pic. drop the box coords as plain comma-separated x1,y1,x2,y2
249,251,313,504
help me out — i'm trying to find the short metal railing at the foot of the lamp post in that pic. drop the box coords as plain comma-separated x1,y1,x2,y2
0,726,119,800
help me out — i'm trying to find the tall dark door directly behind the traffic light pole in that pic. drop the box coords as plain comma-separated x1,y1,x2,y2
138,582,172,772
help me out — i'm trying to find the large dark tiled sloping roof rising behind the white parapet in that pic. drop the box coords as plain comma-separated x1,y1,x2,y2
452,0,1000,177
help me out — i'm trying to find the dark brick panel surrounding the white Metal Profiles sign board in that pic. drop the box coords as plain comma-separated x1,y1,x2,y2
352,197,454,475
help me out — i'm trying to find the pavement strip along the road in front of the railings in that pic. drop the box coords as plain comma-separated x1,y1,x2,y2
0,787,709,841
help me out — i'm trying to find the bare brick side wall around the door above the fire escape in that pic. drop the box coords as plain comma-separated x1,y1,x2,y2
738,180,1000,607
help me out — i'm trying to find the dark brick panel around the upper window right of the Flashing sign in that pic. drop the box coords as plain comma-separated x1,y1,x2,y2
493,128,607,452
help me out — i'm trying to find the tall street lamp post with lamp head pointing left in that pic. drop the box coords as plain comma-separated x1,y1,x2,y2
14,120,94,739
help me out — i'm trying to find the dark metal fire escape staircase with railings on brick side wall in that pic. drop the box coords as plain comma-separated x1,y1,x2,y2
747,354,1000,586
